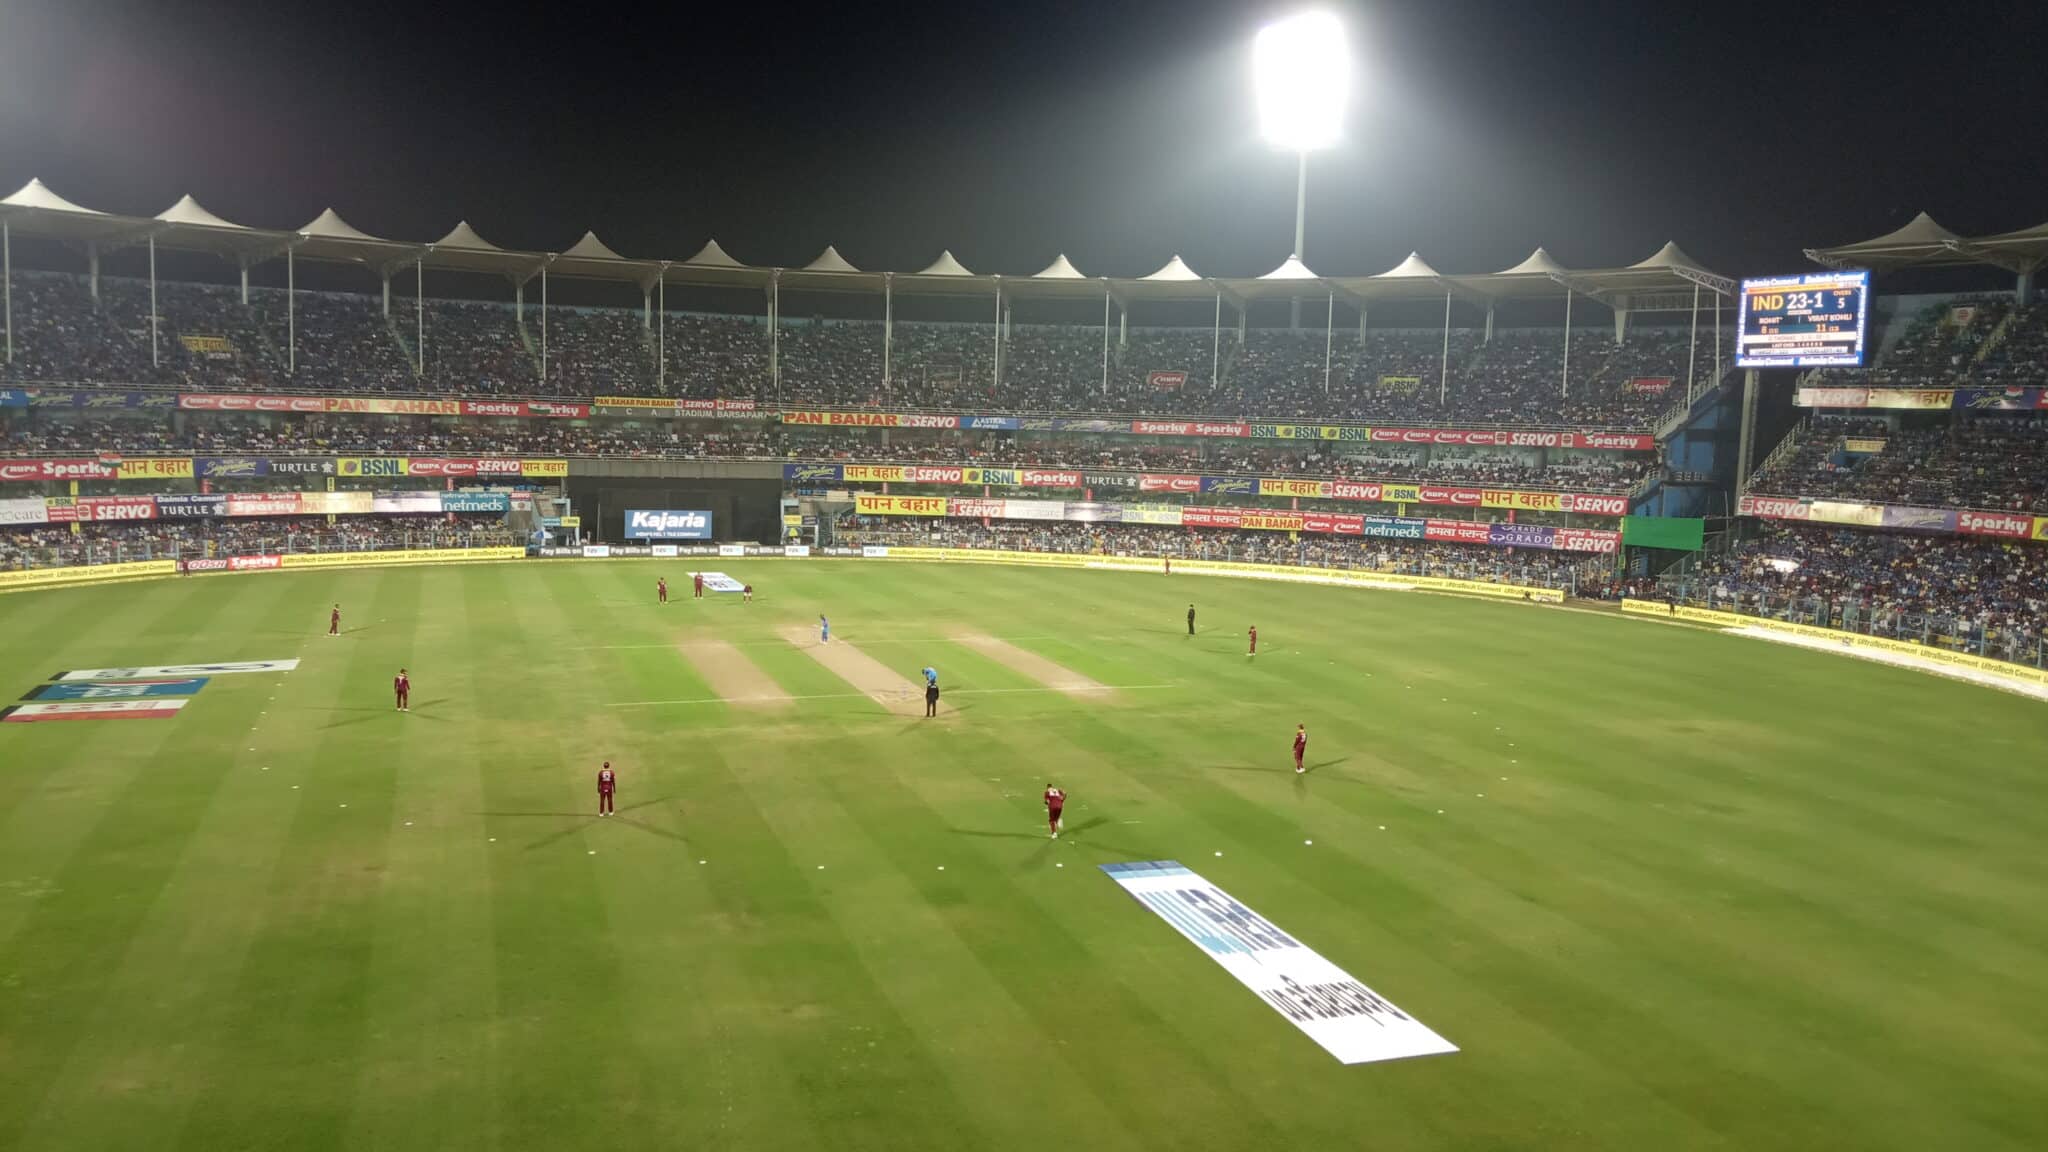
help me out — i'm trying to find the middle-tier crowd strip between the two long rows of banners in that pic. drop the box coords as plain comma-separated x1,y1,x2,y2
0,414,1655,492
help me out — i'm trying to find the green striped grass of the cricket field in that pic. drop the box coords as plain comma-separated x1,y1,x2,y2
0,560,2048,1152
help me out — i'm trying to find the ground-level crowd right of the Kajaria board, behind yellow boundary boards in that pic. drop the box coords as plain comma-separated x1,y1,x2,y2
834,515,1614,588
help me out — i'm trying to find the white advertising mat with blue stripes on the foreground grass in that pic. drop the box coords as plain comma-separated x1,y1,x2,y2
1102,861,1458,1064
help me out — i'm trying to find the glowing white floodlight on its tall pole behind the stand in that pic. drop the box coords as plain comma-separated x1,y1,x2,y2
1251,10,1352,328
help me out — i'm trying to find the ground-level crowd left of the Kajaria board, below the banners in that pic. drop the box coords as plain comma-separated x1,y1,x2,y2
0,515,520,570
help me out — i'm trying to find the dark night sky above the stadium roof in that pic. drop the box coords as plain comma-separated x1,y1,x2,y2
0,0,2048,284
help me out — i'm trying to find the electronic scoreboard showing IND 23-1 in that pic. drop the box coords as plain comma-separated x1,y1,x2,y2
1735,271,1870,369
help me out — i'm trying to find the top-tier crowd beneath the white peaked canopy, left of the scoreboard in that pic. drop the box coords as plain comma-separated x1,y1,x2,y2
0,273,1761,426
